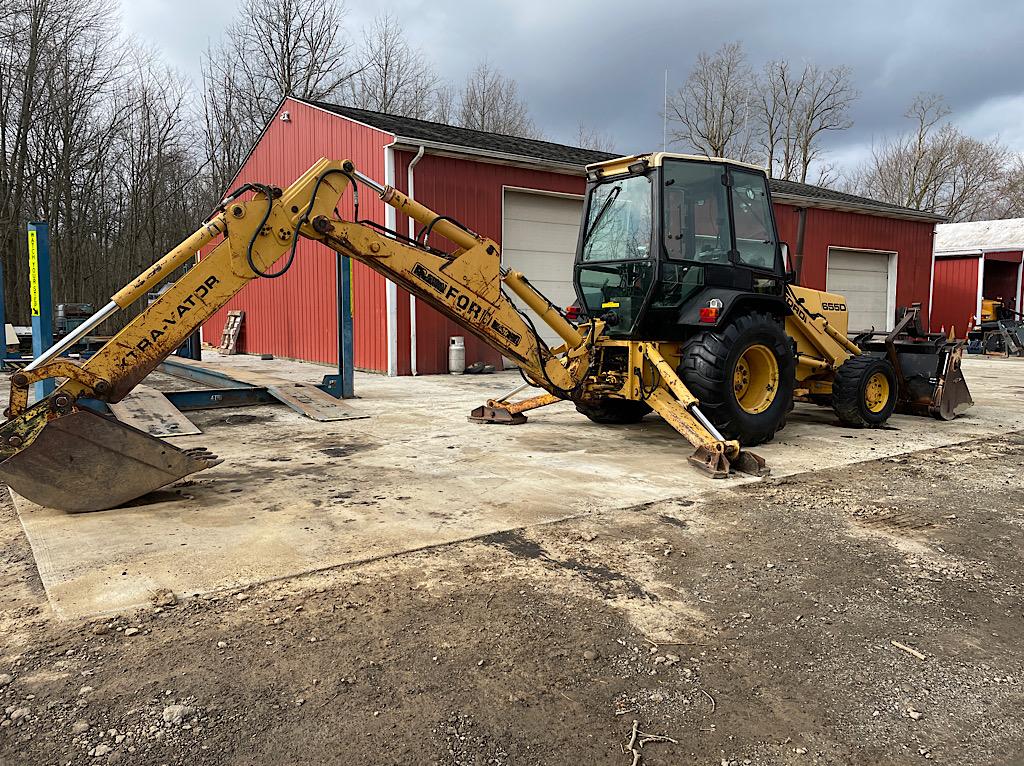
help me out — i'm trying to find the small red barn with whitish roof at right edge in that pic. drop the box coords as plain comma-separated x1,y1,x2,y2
932,218,1024,337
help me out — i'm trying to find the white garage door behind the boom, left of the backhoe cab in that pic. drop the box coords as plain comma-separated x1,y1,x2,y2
502,190,583,345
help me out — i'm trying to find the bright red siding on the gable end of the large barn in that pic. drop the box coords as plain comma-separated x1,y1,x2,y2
204,99,392,371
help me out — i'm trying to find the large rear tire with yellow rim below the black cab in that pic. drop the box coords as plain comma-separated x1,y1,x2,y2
677,311,797,446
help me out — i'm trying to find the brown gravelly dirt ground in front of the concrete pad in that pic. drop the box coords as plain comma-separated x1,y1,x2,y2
0,433,1024,766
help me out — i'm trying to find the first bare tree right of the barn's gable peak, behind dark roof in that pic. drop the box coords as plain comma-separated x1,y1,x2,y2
348,13,437,119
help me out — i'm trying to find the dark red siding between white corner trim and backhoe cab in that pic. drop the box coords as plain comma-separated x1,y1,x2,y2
395,152,586,375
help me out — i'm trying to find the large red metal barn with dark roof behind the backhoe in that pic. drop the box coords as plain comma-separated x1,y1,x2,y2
205,98,940,375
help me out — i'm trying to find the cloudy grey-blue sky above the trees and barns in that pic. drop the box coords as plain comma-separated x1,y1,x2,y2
122,0,1024,171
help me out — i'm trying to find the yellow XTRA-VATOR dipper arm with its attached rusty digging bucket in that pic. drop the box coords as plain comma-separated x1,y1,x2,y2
0,160,356,511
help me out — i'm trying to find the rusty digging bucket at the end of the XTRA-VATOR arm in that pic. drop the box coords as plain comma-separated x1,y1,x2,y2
0,410,221,512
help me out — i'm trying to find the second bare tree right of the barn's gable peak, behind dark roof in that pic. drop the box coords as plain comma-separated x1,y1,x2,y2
458,59,541,138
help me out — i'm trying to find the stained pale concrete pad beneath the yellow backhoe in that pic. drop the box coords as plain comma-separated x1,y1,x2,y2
9,355,1024,616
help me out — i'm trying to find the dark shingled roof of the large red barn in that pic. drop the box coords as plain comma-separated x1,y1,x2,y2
296,99,945,222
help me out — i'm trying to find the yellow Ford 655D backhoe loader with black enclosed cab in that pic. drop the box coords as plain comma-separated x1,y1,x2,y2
0,154,971,511
